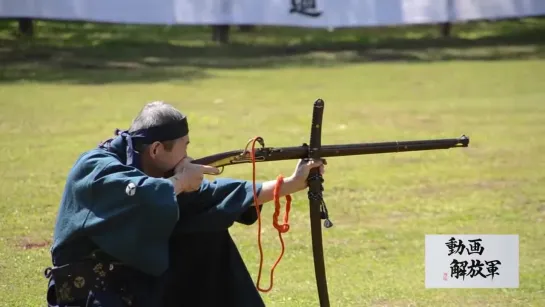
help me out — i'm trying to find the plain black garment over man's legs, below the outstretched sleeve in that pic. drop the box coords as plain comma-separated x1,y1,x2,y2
162,230,265,307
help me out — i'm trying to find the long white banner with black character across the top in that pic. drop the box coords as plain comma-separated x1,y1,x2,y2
0,0,545,28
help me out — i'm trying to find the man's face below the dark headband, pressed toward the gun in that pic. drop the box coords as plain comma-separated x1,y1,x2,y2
150,135,189,172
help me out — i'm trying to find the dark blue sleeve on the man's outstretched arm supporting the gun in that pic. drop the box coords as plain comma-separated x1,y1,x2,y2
174,178,262,234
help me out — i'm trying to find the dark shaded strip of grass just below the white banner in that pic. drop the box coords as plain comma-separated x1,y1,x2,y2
0,19,545,84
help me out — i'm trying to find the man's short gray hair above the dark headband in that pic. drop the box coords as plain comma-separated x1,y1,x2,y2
129,101,185,132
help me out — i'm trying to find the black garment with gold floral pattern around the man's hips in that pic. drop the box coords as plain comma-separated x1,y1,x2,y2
46,240,164,307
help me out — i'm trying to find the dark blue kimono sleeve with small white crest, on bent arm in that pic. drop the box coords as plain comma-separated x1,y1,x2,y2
78,154,179,275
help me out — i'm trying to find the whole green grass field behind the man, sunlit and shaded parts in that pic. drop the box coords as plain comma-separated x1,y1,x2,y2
0,20,545,307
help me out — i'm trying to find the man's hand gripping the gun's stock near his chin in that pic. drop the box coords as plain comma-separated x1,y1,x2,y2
174,157,220,194
